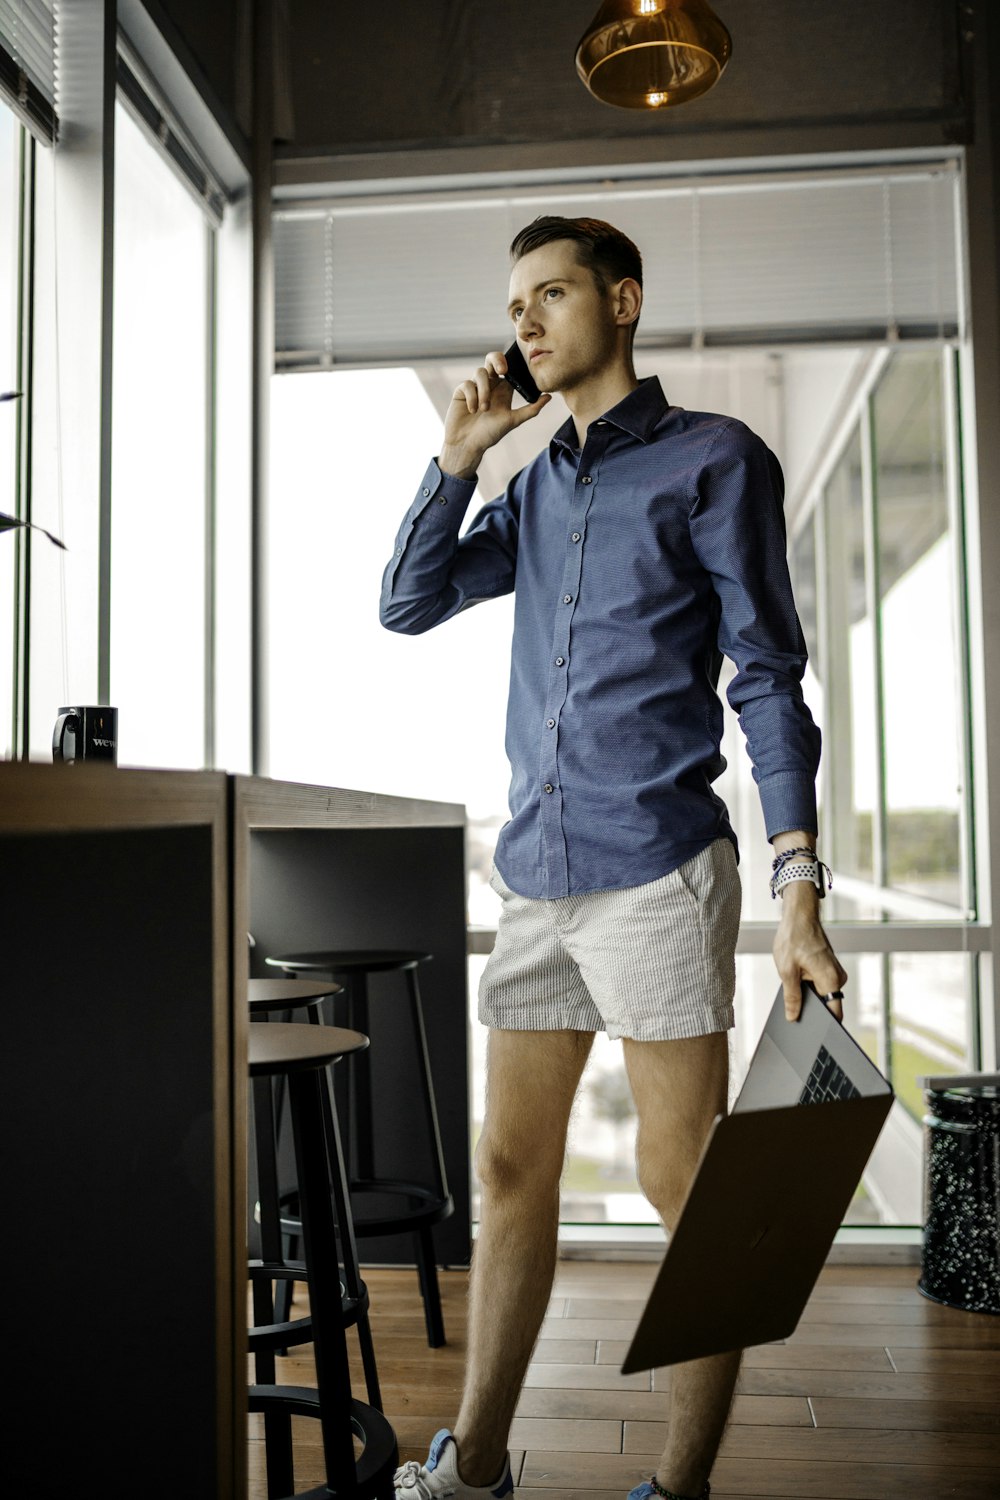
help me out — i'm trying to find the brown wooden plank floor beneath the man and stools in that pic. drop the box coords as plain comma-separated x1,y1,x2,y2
249,1262,1000,1500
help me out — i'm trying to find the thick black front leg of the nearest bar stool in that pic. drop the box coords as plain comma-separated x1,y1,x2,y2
288,1071,357,1500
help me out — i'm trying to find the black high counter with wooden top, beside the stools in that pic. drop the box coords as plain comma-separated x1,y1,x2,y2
0,764,471,1500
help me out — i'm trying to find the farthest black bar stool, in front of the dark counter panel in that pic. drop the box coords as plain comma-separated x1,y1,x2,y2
267,948,454,1349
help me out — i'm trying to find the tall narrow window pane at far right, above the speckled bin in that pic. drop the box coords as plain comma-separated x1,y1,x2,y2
873,351,966,906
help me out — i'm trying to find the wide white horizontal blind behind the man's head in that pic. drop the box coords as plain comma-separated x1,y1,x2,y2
274,162,963,369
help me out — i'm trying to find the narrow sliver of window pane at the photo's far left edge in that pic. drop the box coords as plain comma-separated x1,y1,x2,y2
0,104,21,758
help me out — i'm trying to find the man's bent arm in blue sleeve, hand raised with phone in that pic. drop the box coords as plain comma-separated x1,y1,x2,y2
379,354,549,635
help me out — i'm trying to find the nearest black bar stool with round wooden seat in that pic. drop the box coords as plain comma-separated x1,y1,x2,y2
249,1022,399,1500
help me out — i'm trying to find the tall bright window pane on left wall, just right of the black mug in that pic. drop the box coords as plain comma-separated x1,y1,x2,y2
111,105,208,768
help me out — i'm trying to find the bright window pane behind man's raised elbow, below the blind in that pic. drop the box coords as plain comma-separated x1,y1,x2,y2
268,360,513,858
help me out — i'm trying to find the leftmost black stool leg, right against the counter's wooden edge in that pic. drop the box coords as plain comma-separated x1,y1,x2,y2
252,1079,292,1496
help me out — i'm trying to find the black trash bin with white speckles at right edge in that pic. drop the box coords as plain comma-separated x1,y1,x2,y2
918,1073,1000,1313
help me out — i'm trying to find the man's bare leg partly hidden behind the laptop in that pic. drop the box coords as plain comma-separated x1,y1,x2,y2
622,1032,742,1496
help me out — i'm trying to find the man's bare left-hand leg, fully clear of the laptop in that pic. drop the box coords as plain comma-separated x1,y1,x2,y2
454,1031,594,1485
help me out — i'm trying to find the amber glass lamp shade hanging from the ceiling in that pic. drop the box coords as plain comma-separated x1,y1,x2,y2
576,0,733,110
